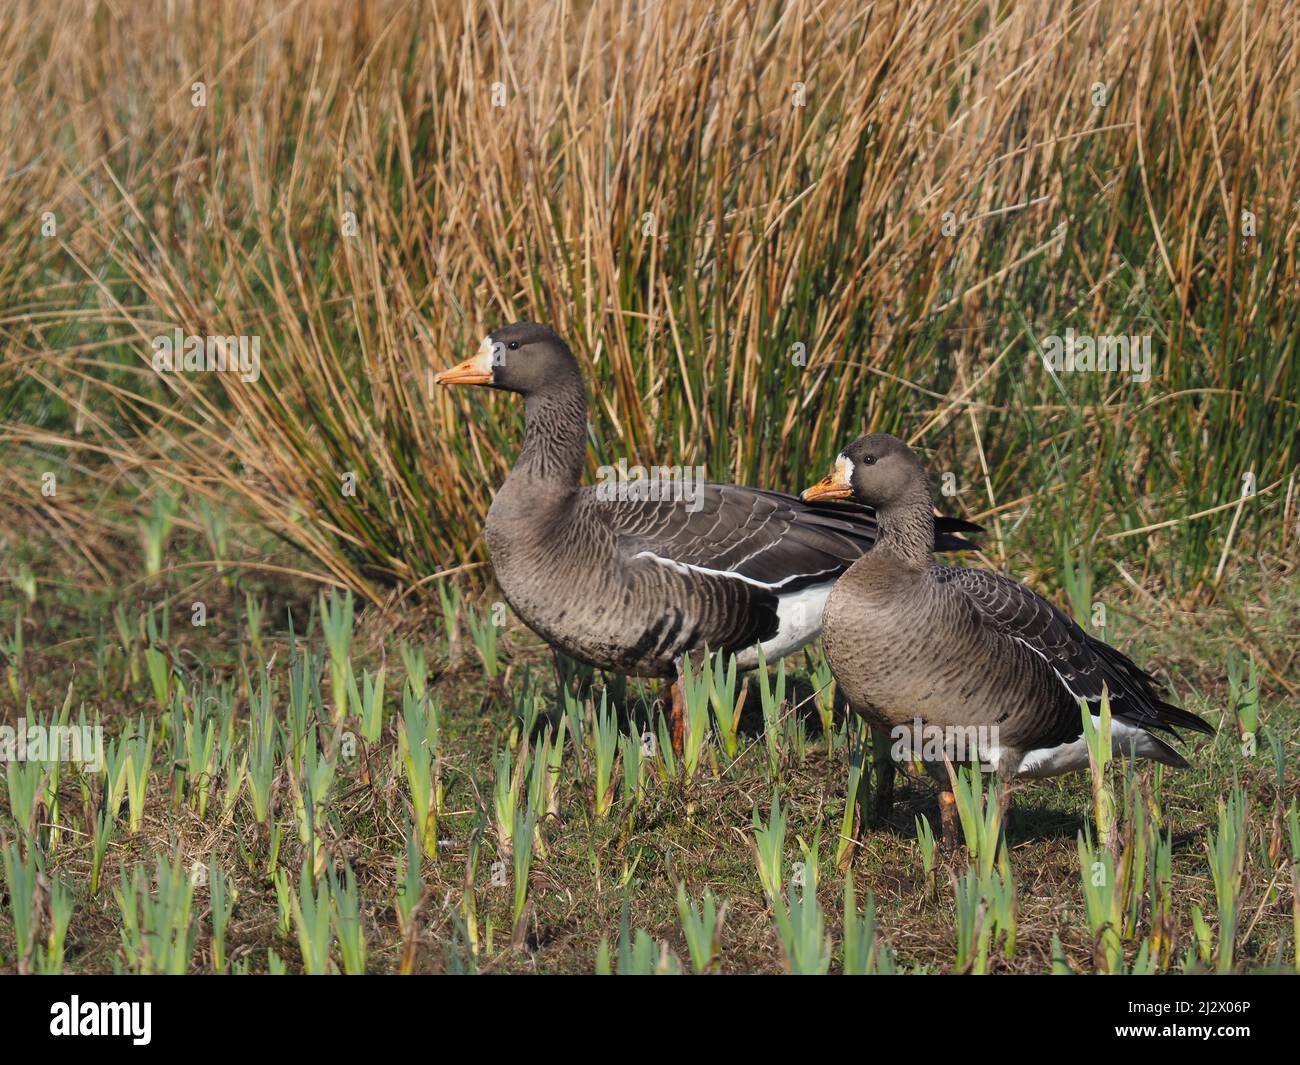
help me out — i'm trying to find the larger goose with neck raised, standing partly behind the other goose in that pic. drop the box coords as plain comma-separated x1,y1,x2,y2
434,322,979,749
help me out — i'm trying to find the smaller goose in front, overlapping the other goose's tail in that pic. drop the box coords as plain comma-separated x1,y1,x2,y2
802,433,1214,847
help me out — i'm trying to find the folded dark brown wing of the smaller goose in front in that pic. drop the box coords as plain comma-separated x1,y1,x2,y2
936,567,1213,741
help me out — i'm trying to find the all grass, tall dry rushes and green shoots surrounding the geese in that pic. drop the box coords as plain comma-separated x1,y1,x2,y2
0,0,1300,973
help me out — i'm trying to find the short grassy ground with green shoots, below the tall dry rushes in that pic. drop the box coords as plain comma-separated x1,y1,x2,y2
0,561,1300,973
